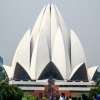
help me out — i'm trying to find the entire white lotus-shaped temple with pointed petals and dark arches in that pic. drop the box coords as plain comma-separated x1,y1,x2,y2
4,4,96,81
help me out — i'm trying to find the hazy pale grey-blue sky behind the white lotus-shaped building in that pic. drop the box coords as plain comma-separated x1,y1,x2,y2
0,0,100,66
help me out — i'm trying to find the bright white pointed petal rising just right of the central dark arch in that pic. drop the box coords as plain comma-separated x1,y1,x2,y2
52,28,70,79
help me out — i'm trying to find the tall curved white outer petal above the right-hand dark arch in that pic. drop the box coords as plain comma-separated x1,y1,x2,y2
71,30,86,68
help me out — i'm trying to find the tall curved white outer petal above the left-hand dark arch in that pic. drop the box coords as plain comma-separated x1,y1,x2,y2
11,30,30,75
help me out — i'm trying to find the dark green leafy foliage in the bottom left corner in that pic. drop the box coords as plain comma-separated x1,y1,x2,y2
0,81,23,100
